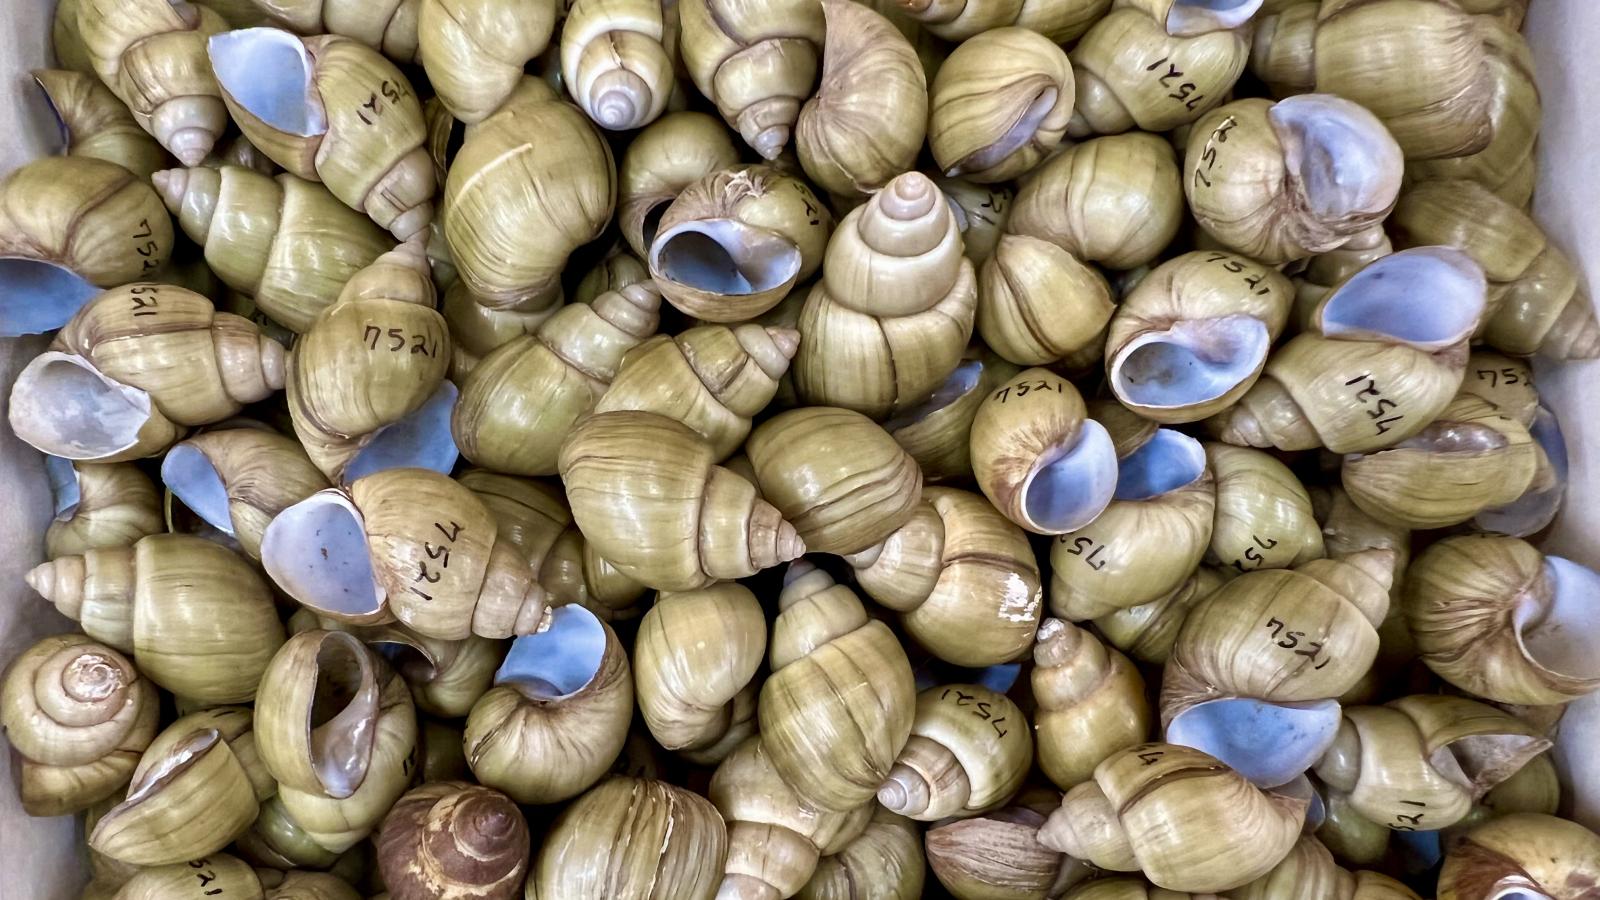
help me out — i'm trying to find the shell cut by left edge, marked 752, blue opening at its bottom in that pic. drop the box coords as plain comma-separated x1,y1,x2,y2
0,153,173,336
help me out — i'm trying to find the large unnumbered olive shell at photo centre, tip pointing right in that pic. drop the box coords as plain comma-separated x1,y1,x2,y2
560,412,805,591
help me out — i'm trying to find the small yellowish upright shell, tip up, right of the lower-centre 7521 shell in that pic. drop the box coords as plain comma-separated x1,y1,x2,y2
1030,618,1150,791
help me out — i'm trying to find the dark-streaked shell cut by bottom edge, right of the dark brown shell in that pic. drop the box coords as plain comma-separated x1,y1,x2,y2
526,777,728,900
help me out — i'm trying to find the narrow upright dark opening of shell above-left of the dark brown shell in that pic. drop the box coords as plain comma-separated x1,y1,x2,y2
307,631,378,799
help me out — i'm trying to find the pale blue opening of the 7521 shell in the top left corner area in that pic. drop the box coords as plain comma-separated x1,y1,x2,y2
208,29,328,138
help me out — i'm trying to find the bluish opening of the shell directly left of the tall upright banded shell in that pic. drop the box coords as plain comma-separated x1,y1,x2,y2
650,219,800,295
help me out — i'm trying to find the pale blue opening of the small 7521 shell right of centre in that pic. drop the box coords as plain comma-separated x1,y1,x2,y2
1022,418,1117,533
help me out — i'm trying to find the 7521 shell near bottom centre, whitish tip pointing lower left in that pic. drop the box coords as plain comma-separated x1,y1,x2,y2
878,684,1034,822
